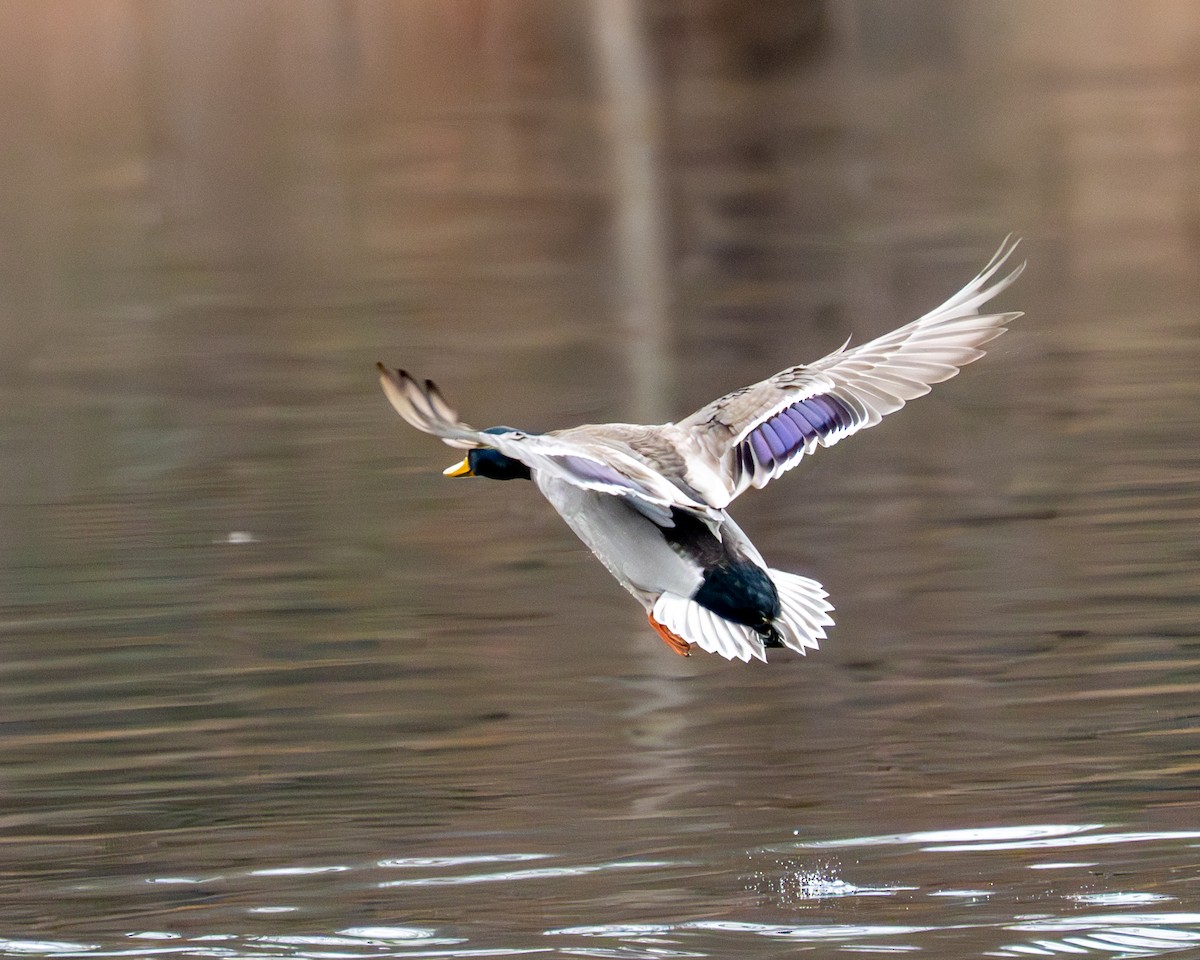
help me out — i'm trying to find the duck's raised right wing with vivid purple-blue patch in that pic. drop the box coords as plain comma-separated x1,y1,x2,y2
679,238,1025,508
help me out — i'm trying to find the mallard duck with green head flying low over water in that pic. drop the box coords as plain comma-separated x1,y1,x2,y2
378,240,1025,661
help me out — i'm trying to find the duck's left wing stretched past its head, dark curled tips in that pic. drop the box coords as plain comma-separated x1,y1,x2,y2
377,364,719,527
